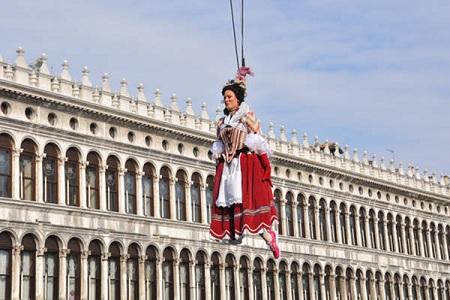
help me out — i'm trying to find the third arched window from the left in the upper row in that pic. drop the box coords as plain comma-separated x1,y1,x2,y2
42,143,60,203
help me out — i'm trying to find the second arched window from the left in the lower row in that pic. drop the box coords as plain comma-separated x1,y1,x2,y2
20,234,36,299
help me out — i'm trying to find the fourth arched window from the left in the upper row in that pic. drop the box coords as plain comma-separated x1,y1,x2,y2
64,148,80,206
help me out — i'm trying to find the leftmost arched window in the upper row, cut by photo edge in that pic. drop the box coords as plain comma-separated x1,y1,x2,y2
0,133,14,198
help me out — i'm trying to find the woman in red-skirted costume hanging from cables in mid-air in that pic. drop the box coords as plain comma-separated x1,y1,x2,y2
210,67,280,258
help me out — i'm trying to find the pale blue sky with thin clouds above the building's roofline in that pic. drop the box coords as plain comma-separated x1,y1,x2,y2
0,0,450,174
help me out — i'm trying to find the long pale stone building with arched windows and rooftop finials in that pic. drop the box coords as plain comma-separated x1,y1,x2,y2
0,48,450,300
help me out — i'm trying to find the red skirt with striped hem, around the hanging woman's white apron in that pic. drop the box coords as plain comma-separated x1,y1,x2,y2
210,153,278,239
